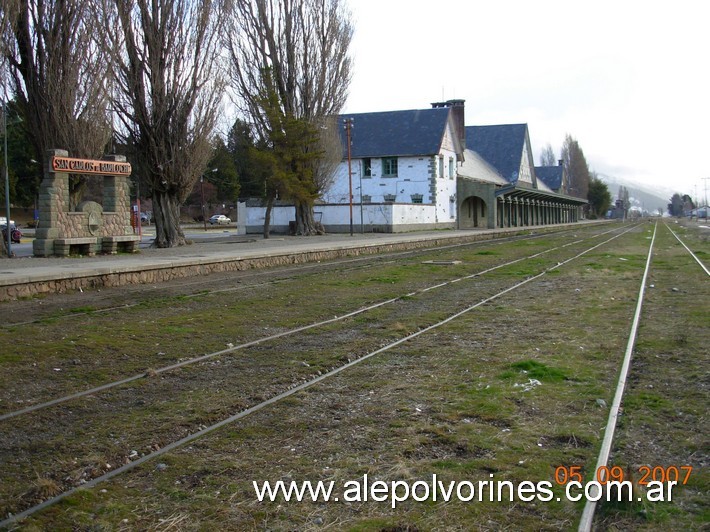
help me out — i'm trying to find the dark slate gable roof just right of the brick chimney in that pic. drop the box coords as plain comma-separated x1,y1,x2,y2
466,124,528,183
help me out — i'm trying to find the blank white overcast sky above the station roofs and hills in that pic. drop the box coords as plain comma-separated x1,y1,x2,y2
344,0,710,202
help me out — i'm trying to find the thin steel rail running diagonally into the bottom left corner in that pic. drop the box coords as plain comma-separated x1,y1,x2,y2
0,226,636,528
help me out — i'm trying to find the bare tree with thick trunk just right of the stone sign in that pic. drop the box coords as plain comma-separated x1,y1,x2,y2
96,0,224,247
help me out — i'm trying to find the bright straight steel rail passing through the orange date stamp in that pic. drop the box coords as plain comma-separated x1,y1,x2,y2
578,222,658,532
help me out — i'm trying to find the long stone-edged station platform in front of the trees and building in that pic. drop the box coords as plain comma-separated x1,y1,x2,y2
0,222,598,301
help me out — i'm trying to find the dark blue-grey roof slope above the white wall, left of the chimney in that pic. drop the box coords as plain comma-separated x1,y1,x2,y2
338,108,456,158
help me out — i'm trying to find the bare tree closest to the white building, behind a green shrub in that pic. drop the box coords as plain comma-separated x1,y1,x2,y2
224,0,353,235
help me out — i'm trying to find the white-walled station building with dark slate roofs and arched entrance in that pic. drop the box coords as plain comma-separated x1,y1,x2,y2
247,100,587,232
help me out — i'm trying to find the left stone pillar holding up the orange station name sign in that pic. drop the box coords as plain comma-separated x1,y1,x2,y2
32,150,69,257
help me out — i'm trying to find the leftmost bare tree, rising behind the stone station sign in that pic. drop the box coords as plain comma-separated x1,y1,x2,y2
0,0,111,204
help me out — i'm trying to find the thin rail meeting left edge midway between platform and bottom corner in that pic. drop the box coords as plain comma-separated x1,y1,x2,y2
0,222,631,421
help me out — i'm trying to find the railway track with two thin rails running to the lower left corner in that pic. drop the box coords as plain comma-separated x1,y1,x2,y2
0,220,708,526
